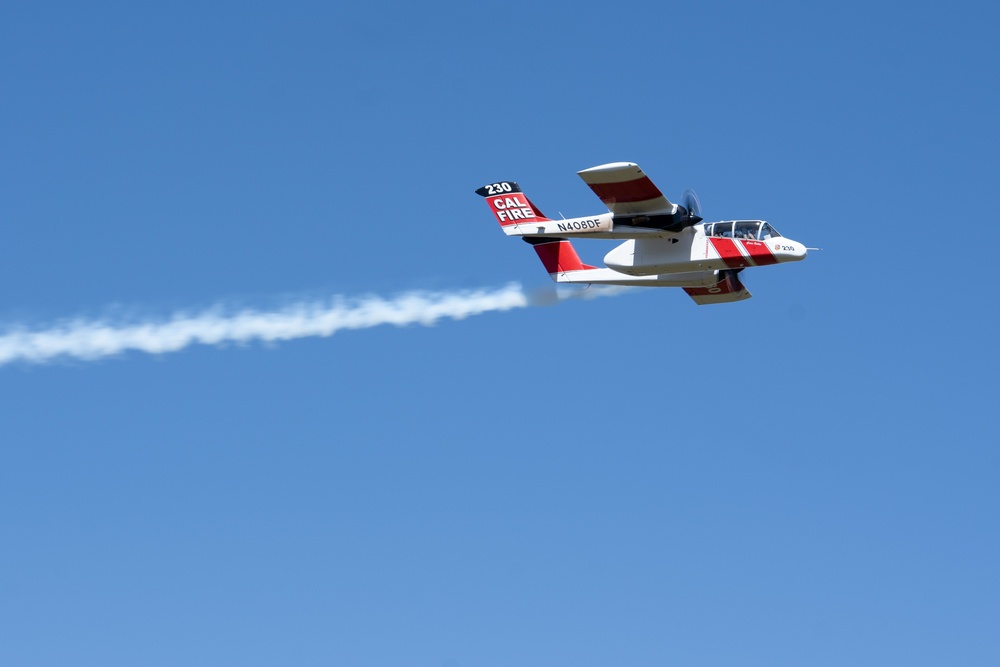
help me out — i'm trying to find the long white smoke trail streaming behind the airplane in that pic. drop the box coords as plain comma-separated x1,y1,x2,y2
0,283,618,366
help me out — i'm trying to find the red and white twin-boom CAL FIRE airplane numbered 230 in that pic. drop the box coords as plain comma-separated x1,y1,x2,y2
476,162,814,305
